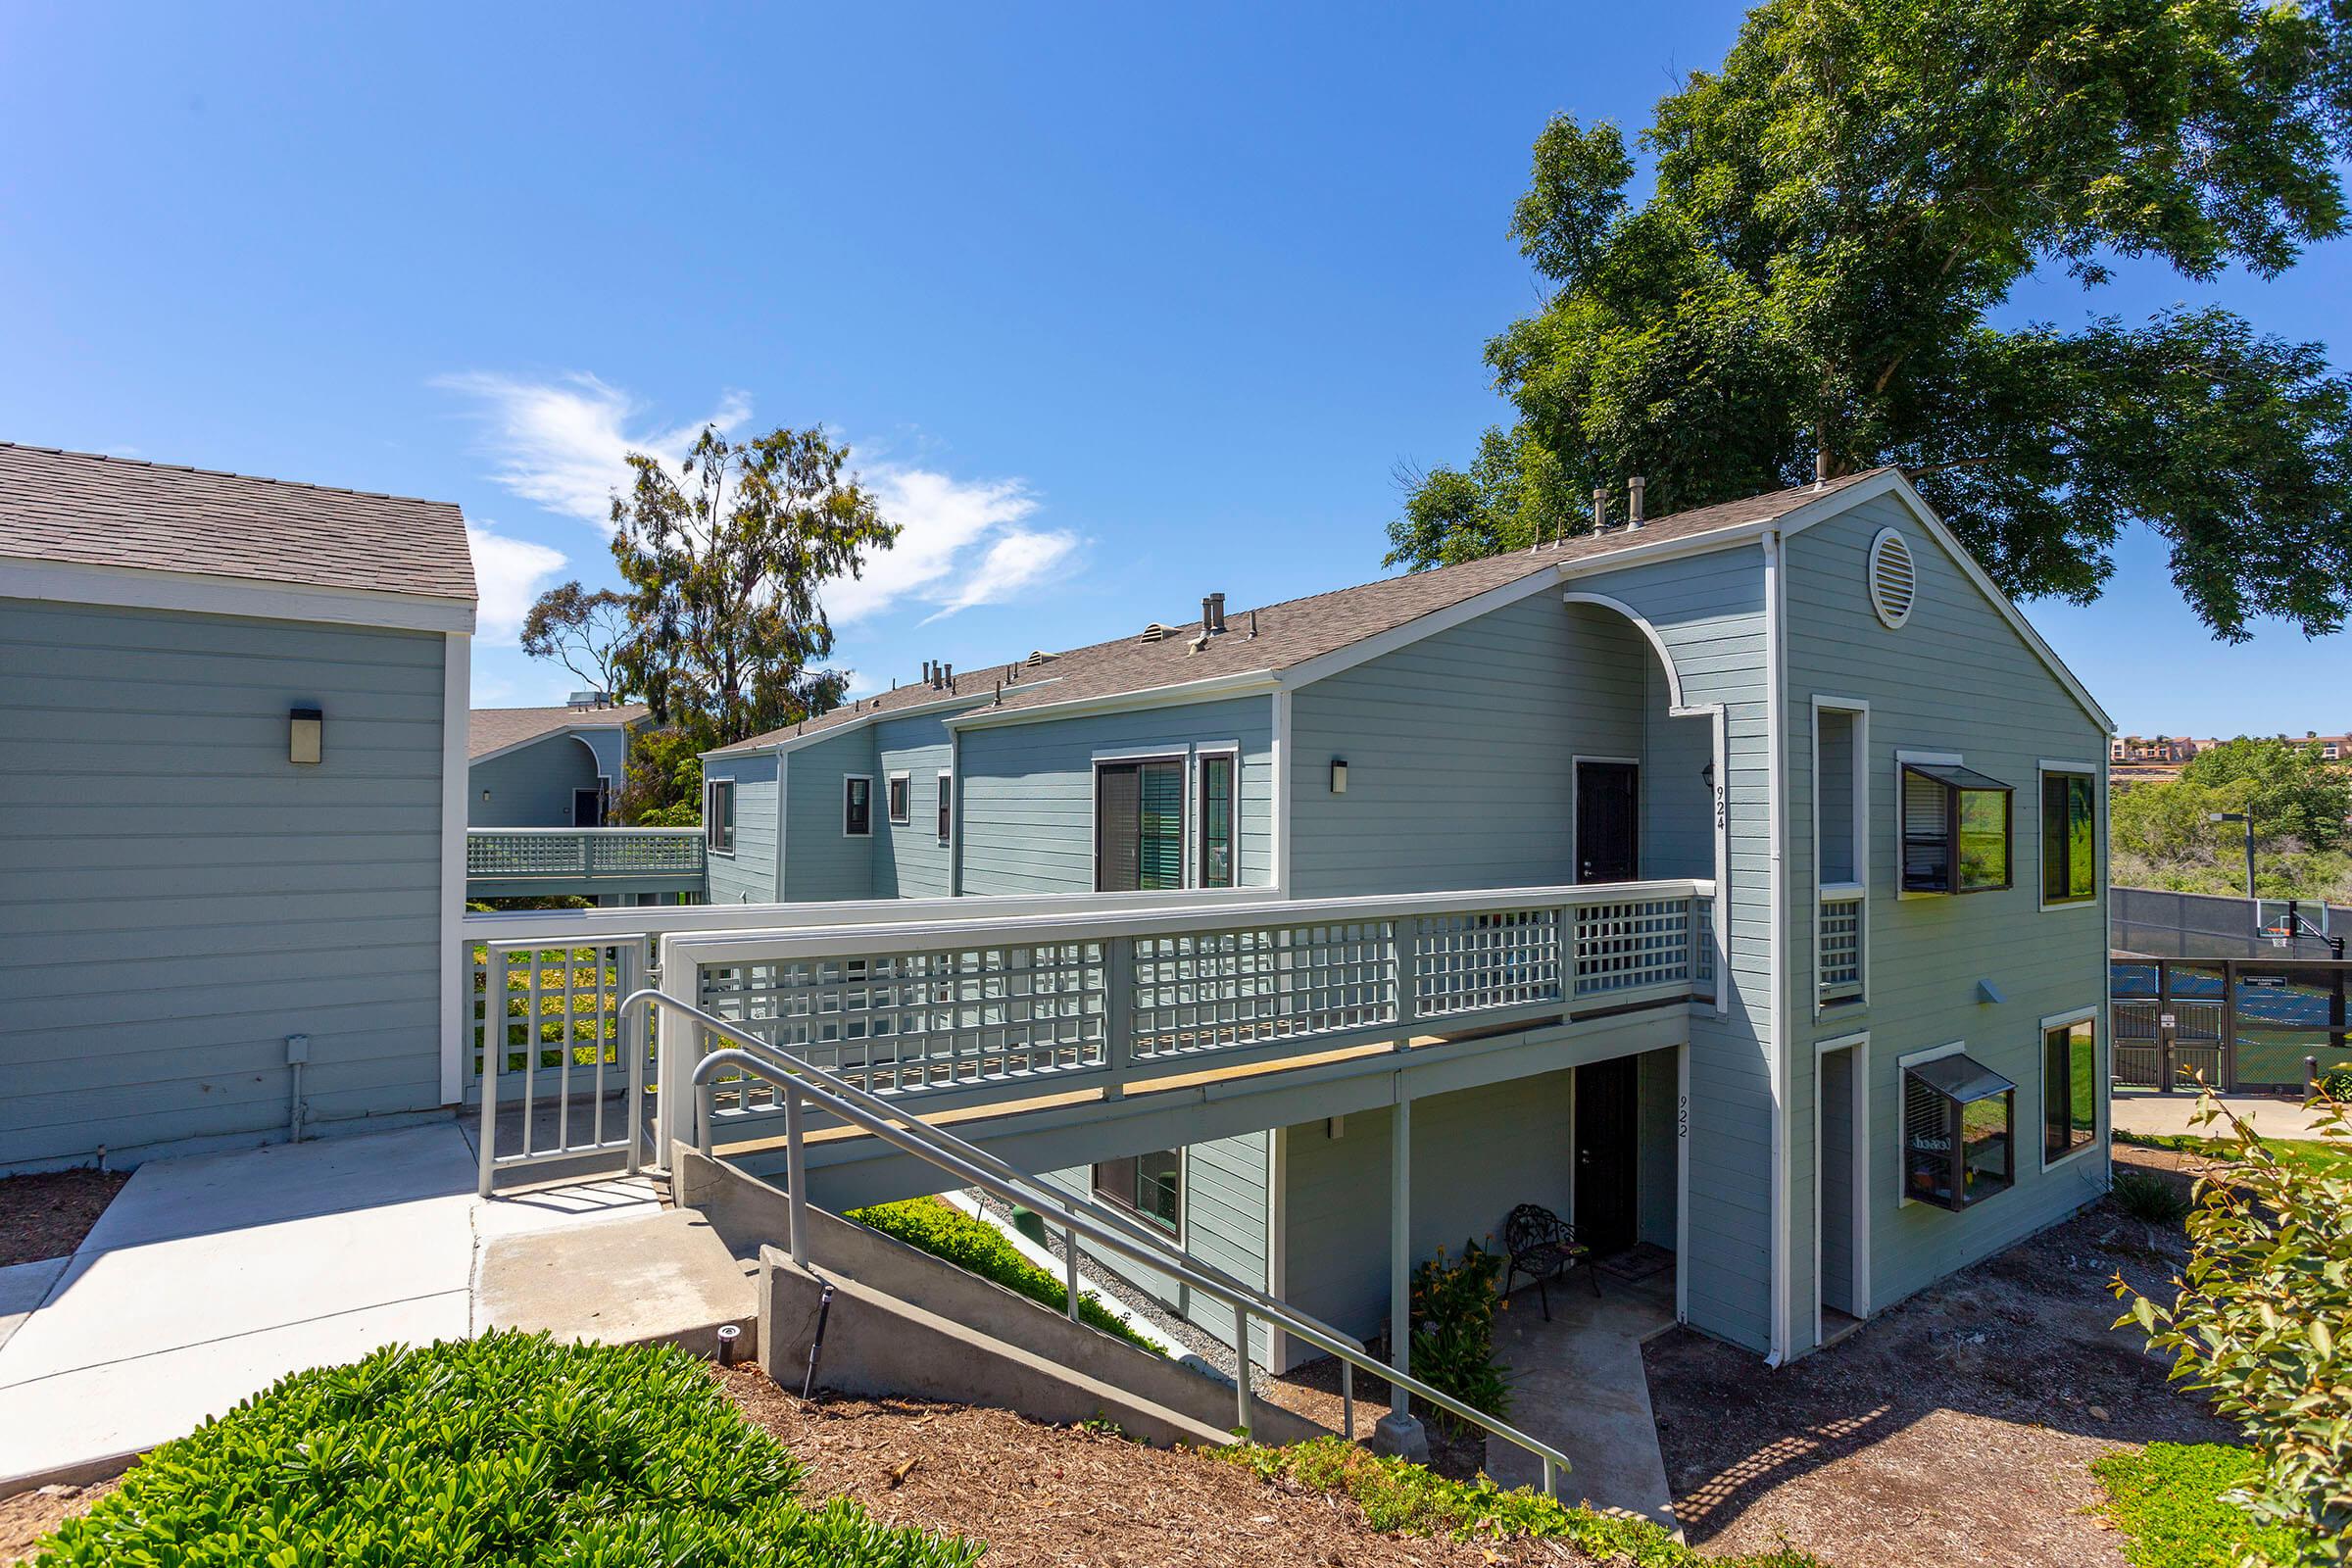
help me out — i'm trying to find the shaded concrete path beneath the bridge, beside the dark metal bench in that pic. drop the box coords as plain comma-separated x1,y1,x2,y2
1487,1269,1677,1531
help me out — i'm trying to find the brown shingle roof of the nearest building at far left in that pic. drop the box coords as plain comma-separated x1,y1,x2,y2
0,442,475,604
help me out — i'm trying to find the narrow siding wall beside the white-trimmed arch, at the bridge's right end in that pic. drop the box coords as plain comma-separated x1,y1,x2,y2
1576,548,1774,1349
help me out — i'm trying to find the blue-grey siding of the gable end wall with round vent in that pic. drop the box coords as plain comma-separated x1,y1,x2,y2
1788,496,2107,1331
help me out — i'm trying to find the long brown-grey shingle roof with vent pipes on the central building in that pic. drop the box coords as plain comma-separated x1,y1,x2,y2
722,467,1884,753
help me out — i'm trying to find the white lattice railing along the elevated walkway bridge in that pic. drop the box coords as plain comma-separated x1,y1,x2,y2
661,882,1715,1116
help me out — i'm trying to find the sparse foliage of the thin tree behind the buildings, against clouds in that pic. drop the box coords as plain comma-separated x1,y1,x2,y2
612,428,899,748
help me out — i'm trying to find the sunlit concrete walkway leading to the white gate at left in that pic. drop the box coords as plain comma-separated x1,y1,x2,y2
0,1121,724,1495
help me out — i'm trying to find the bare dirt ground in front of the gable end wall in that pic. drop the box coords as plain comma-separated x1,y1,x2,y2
1644,1189,2234,1568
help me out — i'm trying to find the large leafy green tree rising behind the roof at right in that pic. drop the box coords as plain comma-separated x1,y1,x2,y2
1390,0,2352,639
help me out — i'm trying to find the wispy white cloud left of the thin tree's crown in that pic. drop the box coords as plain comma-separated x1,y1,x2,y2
433,371,751,526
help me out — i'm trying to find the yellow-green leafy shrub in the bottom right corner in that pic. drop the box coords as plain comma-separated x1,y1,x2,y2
2115,1091,2352,1568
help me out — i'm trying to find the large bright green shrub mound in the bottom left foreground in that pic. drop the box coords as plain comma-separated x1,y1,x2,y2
35,1333,981,1568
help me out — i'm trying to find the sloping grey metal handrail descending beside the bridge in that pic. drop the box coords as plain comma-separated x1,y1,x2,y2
621,990,1569,1493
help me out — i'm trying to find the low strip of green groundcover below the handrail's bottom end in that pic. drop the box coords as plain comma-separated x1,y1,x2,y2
1211,1437,1821,1568
